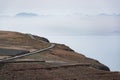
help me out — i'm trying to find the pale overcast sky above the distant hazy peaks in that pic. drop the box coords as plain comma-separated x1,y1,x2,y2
0,0,120,15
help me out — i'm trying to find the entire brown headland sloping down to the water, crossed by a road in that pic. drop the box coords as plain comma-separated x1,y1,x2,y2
0,31,120,80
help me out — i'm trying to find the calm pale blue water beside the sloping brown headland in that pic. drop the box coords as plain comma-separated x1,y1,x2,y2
47,35,120,71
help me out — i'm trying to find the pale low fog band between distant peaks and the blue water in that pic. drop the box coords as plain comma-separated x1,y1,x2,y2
0,13,120,36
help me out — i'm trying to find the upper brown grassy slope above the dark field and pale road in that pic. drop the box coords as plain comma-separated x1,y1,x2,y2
0,31,50,49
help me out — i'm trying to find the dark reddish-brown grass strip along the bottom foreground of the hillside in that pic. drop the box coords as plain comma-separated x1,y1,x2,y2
0,63,120,80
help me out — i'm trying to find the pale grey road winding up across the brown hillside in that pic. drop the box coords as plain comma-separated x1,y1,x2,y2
0,35,55,62
